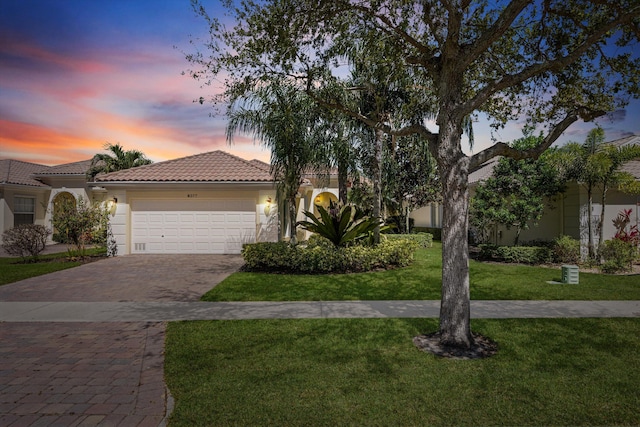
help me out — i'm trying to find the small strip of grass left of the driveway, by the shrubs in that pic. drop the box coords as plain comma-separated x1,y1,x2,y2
0,248,106,285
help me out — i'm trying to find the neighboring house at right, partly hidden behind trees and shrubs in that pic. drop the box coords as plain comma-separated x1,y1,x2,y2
469,135,640,247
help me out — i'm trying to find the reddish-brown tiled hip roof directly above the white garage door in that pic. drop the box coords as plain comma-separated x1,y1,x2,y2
95,151,272,182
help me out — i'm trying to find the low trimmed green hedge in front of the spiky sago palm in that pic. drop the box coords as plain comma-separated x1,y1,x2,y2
242,236,418,273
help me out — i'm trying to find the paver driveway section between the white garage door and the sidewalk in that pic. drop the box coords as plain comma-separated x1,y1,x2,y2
0,255,243,302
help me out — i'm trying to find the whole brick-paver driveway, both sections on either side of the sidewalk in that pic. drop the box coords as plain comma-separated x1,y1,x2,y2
0,255,242,427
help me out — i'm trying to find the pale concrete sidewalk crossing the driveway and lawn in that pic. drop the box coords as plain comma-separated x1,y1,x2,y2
0,300,640,322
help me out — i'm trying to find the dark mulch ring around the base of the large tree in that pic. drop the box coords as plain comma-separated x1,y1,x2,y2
413,332,498,360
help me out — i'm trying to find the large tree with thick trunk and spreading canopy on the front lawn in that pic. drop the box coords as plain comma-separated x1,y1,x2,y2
188,0,640,348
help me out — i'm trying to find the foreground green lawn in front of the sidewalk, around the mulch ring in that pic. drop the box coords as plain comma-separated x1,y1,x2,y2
165,319,640,427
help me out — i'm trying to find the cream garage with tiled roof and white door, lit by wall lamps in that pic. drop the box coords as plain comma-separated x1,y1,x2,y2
90,151,277,255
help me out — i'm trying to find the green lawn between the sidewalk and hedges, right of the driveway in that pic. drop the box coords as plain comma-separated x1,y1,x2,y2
202,243,640,301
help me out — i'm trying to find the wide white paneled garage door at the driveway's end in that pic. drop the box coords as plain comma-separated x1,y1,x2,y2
131,200,256,254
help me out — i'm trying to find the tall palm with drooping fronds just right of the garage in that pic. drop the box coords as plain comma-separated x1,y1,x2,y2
227,83,320,244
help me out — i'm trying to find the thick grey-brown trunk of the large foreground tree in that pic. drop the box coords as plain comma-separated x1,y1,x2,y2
437,126,473,348
